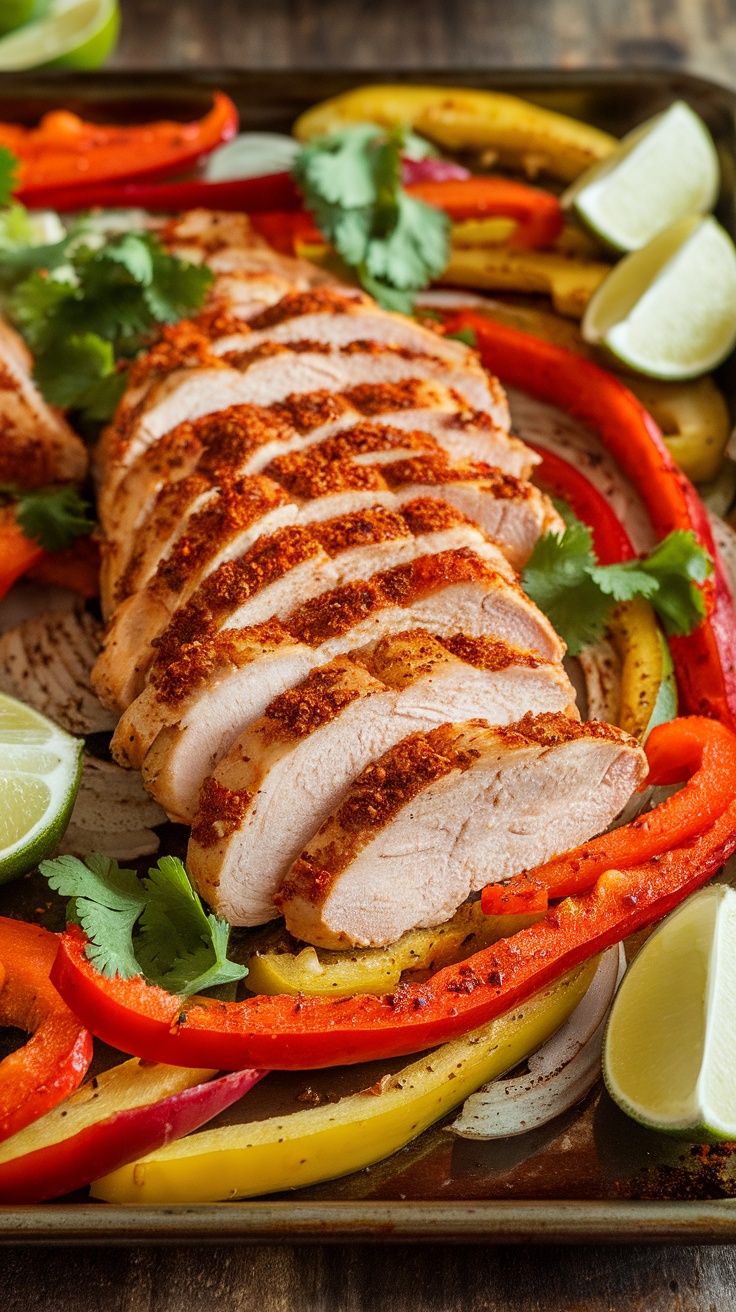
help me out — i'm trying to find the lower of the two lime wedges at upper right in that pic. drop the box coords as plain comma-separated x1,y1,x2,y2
583,218,736,380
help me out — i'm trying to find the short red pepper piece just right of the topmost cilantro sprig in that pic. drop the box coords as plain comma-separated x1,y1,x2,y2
407,177,564,248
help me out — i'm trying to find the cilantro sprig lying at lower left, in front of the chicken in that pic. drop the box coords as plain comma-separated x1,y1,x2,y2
39,853,248,997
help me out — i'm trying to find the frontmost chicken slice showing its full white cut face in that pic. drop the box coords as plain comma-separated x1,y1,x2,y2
274,714,647,947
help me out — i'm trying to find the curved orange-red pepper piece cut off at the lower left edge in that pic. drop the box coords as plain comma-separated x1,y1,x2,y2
0,917,92,1140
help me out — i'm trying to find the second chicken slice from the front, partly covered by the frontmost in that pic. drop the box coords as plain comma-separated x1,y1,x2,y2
181,630,575,925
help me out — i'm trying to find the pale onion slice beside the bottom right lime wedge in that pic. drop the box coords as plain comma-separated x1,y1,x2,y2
449,943,626,1139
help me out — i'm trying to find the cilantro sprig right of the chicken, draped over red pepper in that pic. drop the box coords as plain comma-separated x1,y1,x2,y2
522,502,714,656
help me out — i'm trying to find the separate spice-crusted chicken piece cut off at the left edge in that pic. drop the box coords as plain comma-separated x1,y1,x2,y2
0,320,87,488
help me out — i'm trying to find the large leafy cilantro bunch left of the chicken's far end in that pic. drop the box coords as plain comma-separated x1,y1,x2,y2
0,207,214,422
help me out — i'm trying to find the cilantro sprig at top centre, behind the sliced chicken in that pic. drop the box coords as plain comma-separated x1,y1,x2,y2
294,123,450,314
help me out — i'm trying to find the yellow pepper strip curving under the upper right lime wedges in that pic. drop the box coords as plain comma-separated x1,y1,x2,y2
464,300,731,483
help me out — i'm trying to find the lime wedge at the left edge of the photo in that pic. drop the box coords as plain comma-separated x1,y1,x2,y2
0,693,84,884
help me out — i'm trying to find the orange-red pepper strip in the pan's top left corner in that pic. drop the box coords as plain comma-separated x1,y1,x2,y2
7,91,237,198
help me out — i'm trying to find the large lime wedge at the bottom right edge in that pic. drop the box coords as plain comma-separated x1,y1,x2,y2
603,884,736,1141
